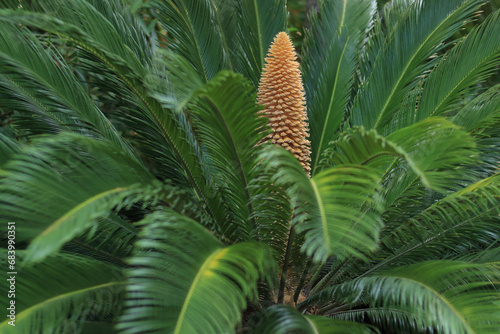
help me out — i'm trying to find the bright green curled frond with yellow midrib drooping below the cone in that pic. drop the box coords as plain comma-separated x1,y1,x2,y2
265,149,383,261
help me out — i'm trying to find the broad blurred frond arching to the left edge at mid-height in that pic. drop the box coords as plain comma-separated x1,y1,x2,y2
0,134,162,261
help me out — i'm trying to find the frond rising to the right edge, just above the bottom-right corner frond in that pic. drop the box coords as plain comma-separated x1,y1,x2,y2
313,175,500,291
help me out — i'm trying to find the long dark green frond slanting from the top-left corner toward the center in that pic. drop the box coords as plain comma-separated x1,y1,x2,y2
0,0,236,227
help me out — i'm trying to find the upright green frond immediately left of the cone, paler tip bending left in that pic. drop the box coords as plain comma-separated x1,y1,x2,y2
148,61,289,248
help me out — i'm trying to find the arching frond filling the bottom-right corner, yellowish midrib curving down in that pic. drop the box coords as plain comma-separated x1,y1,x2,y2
309,261,500,334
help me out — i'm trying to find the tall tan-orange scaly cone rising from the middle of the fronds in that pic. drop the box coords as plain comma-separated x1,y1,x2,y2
258,32,311,173
